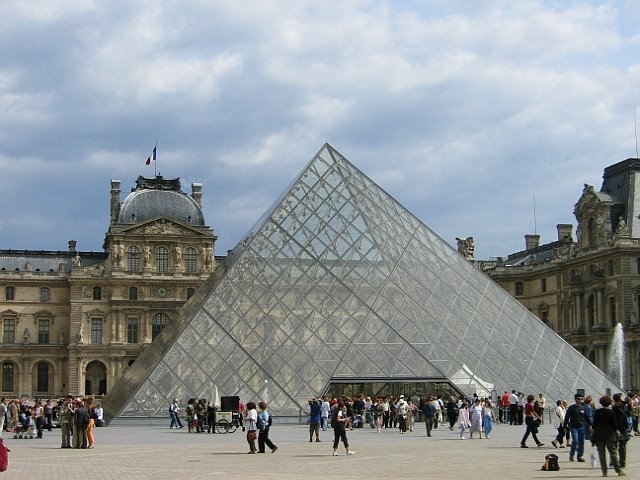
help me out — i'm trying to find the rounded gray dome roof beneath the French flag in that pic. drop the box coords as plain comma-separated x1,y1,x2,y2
118,189,205,226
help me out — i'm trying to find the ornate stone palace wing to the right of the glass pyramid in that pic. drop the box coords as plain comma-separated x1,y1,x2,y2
477,159,640,390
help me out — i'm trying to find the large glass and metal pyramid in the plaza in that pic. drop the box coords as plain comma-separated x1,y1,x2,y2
103,145,619,418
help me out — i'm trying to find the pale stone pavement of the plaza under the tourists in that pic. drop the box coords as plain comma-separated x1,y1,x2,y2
0,419,640,480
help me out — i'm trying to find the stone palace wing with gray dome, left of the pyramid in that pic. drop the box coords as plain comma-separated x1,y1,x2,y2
0,177,217,398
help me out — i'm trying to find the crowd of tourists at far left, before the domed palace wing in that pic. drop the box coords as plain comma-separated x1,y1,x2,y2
0,395,105,448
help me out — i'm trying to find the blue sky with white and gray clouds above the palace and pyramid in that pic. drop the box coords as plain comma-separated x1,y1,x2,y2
0,0,640,258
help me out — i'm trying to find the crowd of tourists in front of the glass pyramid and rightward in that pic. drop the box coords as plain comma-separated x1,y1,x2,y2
164,390,640,476
